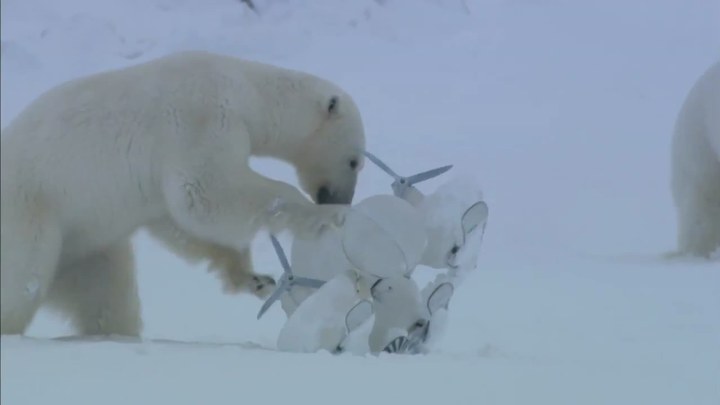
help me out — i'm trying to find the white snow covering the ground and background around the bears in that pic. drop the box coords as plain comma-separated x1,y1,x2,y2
1,0,720,405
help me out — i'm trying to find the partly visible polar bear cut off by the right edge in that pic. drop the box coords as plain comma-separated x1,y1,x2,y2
671,61,720,257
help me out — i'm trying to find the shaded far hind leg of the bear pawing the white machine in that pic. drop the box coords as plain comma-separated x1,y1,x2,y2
46,240,142,337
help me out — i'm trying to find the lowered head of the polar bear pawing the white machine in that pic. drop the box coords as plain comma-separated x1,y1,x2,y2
293,91,365,204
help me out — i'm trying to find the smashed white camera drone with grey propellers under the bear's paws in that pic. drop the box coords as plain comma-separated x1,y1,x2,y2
257,152,488,354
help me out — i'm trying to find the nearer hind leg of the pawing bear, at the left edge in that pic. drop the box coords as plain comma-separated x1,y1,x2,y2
0,206,62,335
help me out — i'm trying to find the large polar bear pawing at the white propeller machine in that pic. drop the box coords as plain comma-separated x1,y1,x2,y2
0,51,365,336
